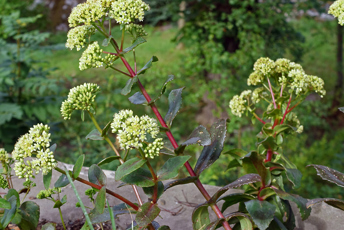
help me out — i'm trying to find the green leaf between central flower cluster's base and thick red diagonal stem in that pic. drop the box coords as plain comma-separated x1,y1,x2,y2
157,156,191,180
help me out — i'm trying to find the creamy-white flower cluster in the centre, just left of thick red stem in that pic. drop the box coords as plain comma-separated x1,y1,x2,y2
111,110,163,157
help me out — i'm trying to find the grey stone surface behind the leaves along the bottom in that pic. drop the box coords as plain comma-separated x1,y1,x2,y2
0,163,344,230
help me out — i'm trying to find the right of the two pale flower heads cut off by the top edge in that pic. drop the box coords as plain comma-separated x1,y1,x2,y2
109,0,149,24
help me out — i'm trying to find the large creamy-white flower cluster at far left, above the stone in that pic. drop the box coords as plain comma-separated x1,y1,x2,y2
12,124,57,180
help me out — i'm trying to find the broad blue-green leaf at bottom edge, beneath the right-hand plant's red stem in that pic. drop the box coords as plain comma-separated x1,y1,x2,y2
245,200,276,230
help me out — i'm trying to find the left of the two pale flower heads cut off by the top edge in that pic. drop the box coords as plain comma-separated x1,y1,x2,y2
68,0,106,27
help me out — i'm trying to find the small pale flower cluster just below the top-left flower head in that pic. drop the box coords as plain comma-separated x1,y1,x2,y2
66,25,96,51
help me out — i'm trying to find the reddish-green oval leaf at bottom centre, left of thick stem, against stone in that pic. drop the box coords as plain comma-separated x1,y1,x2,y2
135,202,160,227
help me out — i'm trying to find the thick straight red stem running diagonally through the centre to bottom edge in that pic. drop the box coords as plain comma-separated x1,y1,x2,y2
121,57,232,230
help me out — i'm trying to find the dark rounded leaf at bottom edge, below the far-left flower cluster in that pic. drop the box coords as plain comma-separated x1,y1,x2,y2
18,201,40,230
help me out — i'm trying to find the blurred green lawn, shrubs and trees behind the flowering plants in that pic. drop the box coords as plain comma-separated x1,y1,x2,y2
0,0,344,198
